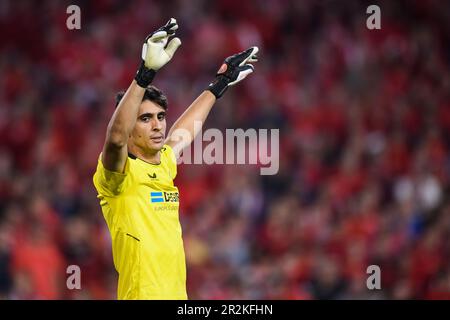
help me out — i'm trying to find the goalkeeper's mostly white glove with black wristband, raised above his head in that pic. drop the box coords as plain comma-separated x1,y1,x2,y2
135,18,181,88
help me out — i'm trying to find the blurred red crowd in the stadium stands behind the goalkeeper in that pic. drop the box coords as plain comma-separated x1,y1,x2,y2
0,0,450,299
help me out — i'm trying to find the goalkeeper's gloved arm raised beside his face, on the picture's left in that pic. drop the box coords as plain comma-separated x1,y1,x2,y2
101,18,181,172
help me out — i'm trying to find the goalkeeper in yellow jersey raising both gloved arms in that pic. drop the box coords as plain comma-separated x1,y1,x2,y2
93,18,258,299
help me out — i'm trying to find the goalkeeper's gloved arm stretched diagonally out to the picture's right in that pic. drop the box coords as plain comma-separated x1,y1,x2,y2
166,47,258,157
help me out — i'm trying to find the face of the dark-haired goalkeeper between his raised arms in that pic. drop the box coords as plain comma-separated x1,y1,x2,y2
130,100,166,152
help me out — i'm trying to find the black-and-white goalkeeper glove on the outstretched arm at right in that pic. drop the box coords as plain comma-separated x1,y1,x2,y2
207,47,259,99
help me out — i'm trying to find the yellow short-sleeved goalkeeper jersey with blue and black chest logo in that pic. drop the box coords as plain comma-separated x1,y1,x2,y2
93,145,187,299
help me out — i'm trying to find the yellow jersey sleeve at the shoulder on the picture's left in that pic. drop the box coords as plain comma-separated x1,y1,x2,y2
93,153,130,197
